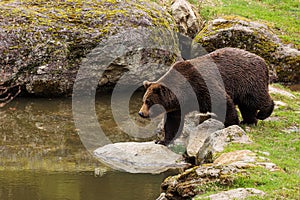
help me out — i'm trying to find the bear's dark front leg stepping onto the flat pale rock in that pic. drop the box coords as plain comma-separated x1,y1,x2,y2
156,110,184,145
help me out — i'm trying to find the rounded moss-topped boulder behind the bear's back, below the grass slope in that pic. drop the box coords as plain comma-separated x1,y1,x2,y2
194,16,300,83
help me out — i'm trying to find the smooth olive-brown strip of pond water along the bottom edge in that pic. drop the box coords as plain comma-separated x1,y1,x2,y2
0,171,164,200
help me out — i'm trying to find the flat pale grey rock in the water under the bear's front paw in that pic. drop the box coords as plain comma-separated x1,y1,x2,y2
94,142,189,174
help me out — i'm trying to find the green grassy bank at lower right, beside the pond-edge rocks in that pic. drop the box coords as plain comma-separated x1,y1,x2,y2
199,85,300,199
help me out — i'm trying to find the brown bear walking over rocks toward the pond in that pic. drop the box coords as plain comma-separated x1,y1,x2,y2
139,48,274,145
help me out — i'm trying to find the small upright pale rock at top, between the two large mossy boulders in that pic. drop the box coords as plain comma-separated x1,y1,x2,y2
171,0,203,38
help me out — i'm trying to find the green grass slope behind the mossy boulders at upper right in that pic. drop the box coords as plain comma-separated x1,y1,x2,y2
197,0,300,48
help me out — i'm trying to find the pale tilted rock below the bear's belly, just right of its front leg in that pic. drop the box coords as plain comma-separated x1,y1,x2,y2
187,119,224,157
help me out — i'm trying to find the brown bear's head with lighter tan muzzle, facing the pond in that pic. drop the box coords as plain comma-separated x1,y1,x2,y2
139,81,178,118
